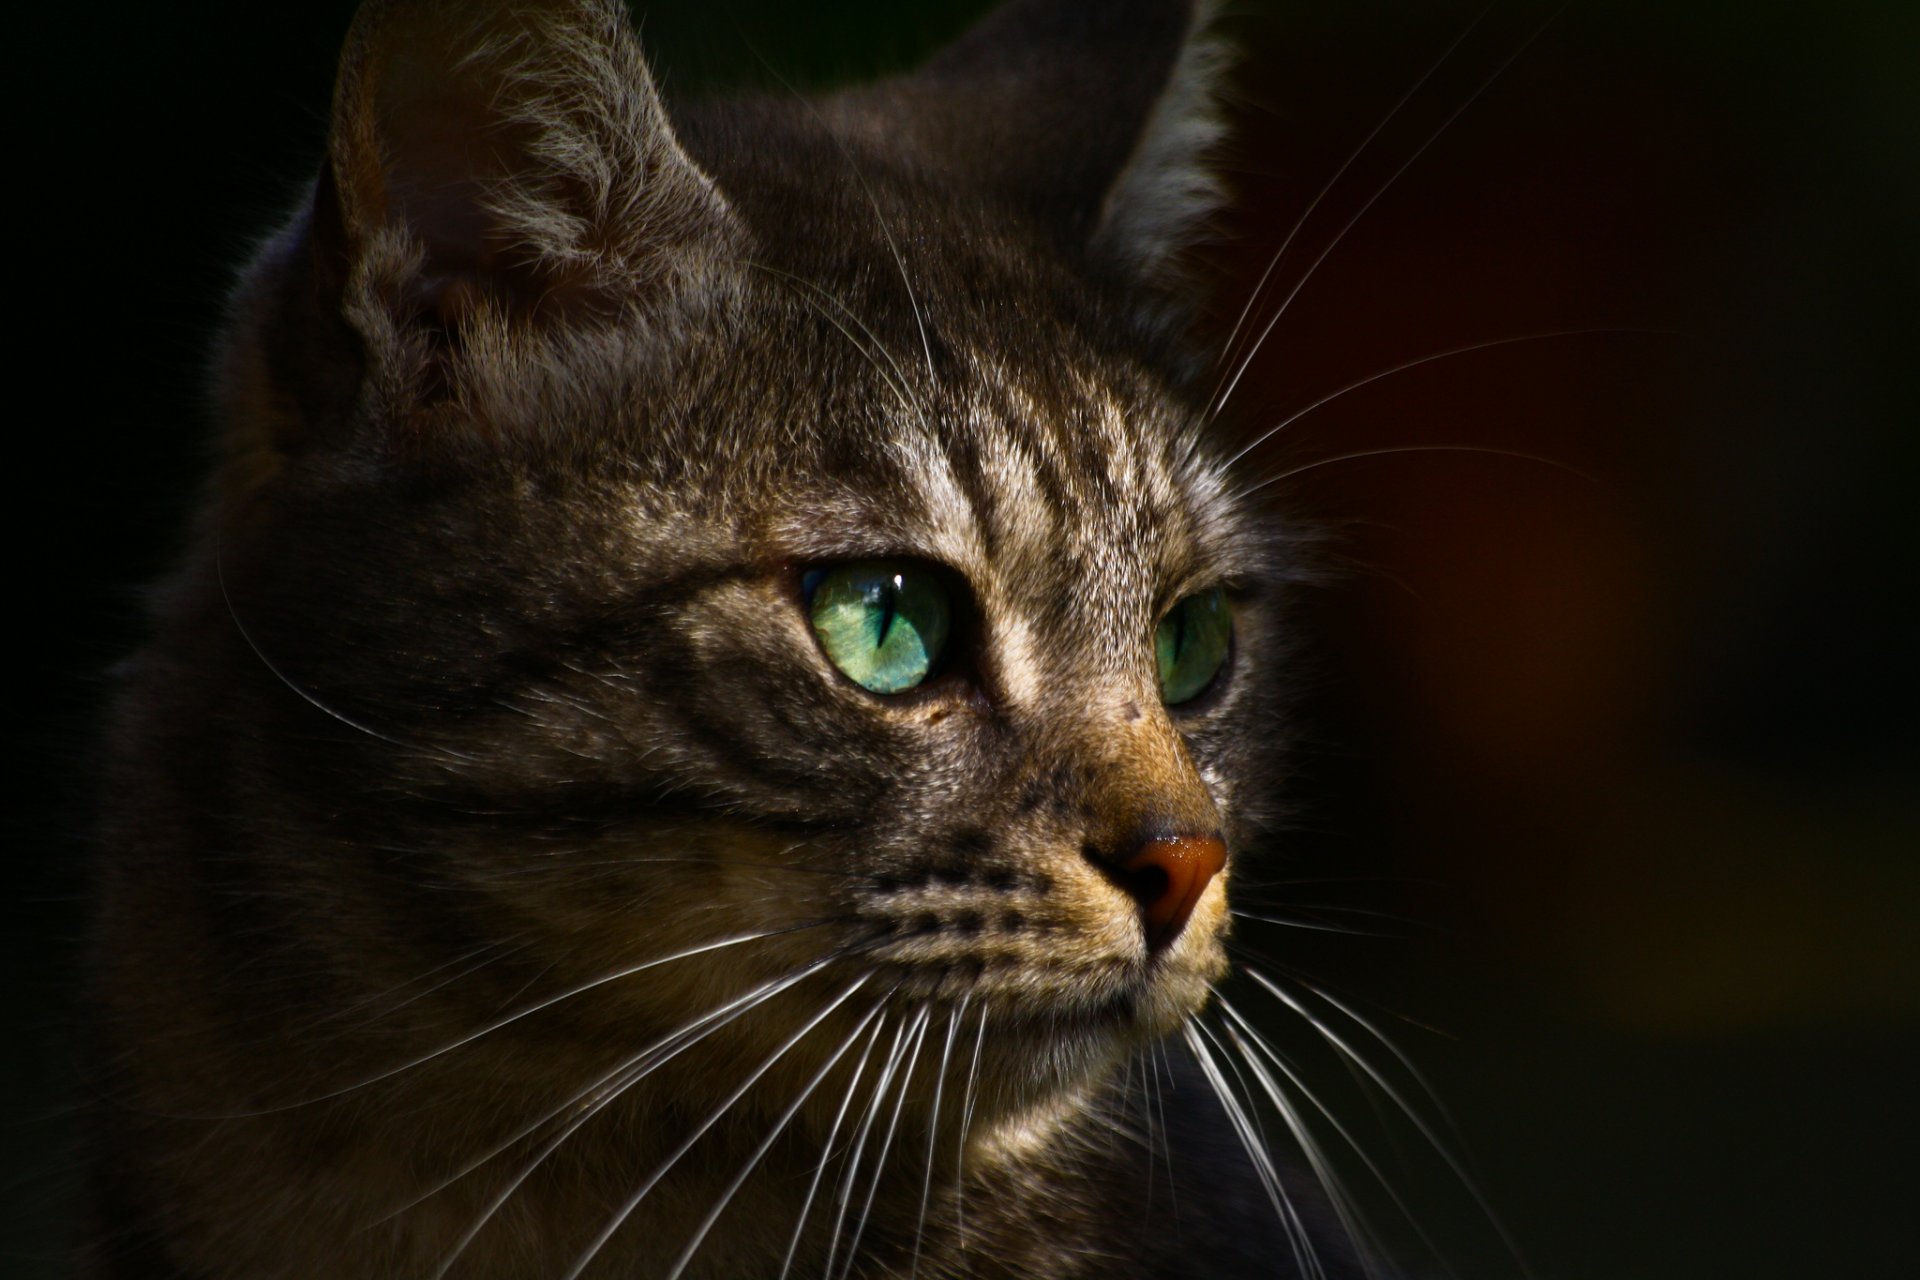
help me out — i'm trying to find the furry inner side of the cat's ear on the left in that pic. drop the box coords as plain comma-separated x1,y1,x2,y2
328,0,730,326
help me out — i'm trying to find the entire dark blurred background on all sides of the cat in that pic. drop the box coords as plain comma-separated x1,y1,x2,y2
0,0,1920,1280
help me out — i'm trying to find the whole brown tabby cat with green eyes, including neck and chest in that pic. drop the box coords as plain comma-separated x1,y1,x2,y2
84,0,1361,1280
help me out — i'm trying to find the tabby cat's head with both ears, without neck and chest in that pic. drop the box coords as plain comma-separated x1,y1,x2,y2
206,0,1281,1136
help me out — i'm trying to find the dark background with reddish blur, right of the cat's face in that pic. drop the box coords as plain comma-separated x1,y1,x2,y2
1190,4,1920,1280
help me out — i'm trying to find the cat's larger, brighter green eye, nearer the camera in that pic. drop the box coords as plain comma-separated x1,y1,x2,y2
804,560,952,693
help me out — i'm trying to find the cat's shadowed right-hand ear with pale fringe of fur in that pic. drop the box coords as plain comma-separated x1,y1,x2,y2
864,0,1229,286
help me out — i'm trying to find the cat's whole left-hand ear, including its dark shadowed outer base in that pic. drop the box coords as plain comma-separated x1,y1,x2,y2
227,0,741,460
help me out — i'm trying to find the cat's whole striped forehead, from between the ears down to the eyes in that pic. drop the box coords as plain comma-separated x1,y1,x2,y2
583,134,1261,635
